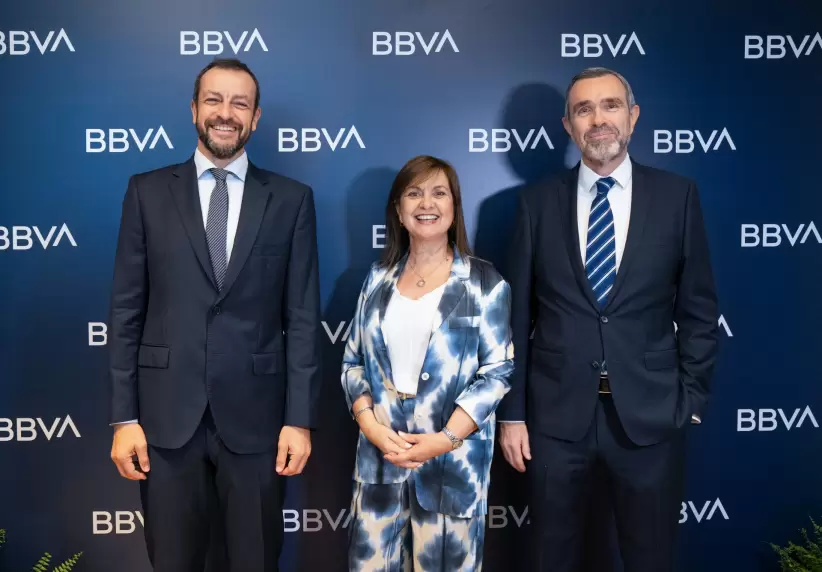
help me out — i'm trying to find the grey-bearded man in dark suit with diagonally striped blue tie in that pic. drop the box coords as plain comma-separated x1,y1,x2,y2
498,68,718,572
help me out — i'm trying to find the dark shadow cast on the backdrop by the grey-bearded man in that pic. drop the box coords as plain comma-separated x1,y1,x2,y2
474,83,622,572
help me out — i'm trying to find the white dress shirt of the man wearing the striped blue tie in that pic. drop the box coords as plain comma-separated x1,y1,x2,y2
500,154,701,423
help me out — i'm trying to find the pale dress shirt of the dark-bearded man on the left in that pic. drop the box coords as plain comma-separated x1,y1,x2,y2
112,149,248,425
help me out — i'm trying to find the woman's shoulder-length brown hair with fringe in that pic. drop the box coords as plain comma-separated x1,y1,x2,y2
381,155,471,268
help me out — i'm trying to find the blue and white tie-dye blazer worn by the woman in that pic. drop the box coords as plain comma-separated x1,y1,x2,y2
342,250,514,518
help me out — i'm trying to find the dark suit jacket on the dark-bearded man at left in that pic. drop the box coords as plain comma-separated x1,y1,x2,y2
109,154,320,453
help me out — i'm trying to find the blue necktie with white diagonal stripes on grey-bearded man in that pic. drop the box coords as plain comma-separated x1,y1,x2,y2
585,177,616,308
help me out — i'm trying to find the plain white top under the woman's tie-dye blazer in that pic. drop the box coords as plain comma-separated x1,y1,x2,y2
382,284,445,395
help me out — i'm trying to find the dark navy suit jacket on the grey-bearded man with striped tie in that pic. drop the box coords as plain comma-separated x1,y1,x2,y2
497,161,718,445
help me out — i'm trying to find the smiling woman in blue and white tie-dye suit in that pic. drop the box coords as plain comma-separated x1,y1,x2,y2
342,156,514,572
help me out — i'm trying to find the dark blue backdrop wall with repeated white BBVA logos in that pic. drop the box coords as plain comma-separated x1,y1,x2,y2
0,0,822,572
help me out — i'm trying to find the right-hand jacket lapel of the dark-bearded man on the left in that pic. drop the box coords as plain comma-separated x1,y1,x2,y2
218,163,271,301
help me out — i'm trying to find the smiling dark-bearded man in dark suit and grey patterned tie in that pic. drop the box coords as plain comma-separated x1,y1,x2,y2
109,60,320,572
